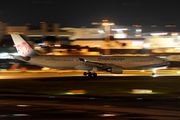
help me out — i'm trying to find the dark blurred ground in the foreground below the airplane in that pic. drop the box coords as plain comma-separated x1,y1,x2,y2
0,76,180,120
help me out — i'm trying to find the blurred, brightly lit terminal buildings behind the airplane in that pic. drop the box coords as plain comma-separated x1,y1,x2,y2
0,22,180,58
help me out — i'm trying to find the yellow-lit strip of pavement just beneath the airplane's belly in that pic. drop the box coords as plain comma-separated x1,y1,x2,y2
0,70,180,79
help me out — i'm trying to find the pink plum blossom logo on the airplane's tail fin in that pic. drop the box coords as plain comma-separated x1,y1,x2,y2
17,42,31,54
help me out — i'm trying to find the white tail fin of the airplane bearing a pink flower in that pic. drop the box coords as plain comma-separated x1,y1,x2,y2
11,34,39,56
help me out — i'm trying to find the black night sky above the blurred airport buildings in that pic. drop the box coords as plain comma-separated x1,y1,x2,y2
0,0,180,27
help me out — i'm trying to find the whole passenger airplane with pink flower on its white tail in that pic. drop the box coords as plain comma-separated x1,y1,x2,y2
11,34,169,77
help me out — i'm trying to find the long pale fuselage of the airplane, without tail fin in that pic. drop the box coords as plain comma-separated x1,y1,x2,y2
14,55,169,70
